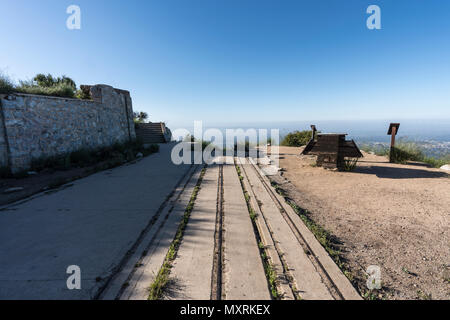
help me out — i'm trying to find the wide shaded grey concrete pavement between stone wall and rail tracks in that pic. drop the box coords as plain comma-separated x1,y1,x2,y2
0,144,190,299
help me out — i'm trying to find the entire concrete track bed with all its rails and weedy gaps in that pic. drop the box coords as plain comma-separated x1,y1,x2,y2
100,158,361,300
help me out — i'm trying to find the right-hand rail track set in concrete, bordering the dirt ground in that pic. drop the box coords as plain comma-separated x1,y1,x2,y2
236,158,360,300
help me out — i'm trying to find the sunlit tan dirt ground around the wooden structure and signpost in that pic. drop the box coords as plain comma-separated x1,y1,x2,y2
272,147,450,299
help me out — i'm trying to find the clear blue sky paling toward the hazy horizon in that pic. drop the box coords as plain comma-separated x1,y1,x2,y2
0,0,450,125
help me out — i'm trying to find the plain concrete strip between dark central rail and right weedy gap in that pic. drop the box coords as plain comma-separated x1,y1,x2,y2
223,165,271,300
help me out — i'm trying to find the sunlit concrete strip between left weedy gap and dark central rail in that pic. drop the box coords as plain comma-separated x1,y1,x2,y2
166,165,219,300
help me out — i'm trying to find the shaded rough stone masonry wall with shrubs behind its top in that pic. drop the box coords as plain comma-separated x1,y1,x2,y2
0,85,136,172
